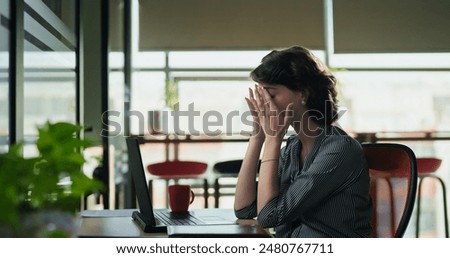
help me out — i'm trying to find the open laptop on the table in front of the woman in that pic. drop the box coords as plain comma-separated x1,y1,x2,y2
126,137,237,233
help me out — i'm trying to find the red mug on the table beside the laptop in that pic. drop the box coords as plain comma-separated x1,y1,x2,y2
169,185,195,212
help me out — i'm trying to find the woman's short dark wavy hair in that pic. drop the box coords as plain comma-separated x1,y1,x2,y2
250,46,338,125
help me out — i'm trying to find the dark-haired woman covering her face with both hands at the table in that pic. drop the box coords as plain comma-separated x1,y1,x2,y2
234,46,372,237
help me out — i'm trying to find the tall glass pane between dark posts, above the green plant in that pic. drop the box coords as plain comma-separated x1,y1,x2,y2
23,0,77,154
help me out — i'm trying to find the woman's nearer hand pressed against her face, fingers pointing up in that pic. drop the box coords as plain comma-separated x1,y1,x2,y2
254,85,294,138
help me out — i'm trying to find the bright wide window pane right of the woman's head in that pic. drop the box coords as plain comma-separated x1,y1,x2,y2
337,71,450,132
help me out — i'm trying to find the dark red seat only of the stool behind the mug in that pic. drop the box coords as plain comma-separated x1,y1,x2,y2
147,160,208,178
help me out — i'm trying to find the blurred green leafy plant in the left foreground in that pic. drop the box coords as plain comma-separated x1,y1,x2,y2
0,122,103,237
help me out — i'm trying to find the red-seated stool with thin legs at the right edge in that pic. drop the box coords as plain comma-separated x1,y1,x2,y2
416,158,449,238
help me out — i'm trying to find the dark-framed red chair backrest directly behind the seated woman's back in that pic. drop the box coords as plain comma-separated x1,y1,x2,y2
362,143,417,237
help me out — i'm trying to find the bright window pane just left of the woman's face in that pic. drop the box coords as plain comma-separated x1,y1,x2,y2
178,78,251,136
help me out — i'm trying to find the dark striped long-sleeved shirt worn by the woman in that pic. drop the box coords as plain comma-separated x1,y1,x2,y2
235,126,372,237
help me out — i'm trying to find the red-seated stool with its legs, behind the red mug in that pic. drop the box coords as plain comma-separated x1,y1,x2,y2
147,160,209,208
